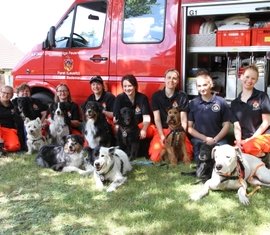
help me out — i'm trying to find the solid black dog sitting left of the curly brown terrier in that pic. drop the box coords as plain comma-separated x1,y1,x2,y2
117,107,140,160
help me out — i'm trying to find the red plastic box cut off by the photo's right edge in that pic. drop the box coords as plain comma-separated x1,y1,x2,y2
251,28,270,46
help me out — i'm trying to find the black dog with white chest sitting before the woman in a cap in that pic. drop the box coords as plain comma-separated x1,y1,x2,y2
84,101,114,149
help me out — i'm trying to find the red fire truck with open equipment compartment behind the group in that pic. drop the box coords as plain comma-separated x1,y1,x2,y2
13,0,270,103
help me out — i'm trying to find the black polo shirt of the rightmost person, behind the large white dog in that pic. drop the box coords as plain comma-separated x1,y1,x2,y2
231,89,270,139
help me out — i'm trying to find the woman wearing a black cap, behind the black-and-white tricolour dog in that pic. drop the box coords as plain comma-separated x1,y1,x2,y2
82,76,115,124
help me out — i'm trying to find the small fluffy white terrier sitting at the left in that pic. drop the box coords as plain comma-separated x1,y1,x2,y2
24,117,47,154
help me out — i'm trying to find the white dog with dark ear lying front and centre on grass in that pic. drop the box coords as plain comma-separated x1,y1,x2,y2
93,147,132,192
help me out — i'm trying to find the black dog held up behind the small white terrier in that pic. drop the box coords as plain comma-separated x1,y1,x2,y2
14,97,36,120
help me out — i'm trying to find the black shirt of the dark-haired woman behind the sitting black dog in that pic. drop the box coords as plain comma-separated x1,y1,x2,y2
113,92,152,124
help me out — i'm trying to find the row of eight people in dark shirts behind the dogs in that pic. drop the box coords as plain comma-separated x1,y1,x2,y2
0,65,270,162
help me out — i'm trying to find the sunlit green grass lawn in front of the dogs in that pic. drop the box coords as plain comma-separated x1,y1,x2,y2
0,155,270,235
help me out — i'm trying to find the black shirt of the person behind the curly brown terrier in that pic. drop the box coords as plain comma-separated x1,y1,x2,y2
152,89,189,128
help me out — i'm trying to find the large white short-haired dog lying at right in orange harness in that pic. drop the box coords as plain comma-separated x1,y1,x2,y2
190,145,270,205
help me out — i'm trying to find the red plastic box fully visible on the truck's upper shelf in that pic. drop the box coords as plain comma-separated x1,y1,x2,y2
216,29,251,47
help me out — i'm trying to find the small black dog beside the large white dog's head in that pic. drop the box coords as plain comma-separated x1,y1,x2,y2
196,143,215,183
